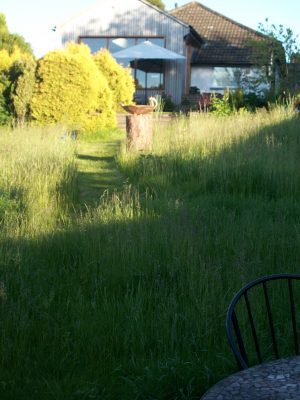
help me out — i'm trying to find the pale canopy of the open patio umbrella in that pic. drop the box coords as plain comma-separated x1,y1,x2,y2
113,40,186,60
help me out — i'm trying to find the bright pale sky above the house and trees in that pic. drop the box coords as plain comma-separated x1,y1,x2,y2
0,0,300,57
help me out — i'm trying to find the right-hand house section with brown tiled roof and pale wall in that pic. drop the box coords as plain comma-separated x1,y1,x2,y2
170,1,279,93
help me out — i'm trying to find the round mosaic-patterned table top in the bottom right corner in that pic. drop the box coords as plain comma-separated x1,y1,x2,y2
202,356,300,400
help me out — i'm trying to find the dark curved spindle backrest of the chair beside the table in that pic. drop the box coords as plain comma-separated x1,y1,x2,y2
226,274,300,369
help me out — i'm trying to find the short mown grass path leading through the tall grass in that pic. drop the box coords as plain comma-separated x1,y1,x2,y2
77,140,124,206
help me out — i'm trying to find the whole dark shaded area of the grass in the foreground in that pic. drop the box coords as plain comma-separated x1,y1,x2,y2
0,114,300,400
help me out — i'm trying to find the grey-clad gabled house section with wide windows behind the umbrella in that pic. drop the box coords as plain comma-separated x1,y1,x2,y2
59,0,201,103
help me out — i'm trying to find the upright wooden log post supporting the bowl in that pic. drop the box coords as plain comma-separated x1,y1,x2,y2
126,113,153,151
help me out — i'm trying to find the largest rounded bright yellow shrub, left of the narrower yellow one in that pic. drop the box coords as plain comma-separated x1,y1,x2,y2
31,43,115,132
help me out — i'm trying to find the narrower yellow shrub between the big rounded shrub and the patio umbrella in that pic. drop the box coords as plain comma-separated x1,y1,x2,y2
94,49,135,109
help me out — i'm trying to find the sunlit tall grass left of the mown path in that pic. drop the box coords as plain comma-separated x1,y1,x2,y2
0,128,76,234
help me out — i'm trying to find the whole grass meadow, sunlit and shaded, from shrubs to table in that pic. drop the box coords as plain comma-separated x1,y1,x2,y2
0,107,300,400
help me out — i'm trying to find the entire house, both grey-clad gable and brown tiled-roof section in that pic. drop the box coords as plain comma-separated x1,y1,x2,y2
59,0,282,104
